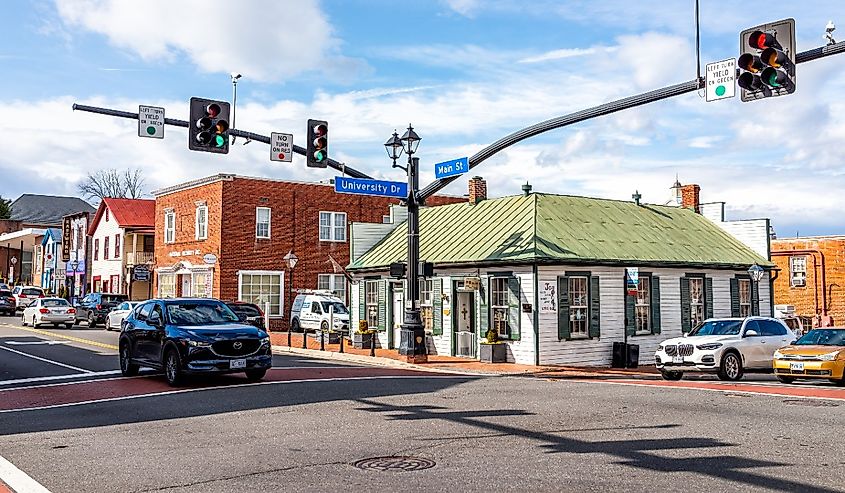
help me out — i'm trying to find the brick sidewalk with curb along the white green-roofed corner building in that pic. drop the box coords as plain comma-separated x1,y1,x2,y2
270,332,659,378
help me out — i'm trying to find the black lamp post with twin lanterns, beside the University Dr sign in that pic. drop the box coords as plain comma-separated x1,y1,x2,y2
384,124,428,363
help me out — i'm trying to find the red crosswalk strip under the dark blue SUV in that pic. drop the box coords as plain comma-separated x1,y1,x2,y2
0,367,454,412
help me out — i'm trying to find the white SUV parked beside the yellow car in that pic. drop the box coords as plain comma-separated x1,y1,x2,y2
654,317,795,380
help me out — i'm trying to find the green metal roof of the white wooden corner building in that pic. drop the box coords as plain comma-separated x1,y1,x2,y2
350,193,773,269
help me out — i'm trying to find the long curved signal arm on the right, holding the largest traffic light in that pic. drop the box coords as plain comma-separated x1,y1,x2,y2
417,42,845,202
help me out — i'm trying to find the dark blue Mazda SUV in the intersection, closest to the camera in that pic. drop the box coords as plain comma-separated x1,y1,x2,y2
119,298,273,386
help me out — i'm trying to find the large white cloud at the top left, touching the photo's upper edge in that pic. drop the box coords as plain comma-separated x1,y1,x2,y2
50,0,346,81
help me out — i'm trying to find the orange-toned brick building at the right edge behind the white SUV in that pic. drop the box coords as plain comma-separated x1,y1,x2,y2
772,236,845,325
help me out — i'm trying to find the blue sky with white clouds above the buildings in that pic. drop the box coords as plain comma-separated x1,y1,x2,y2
0,0,845,237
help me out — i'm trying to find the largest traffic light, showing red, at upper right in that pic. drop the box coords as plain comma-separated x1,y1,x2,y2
737,19,795,101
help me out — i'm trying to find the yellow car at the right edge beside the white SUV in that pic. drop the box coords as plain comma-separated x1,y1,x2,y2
772,327,845,385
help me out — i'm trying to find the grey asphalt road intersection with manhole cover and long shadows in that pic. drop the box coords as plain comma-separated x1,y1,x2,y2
0,318,845,493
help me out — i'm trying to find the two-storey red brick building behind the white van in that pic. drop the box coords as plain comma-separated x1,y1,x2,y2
148,174,458,329
